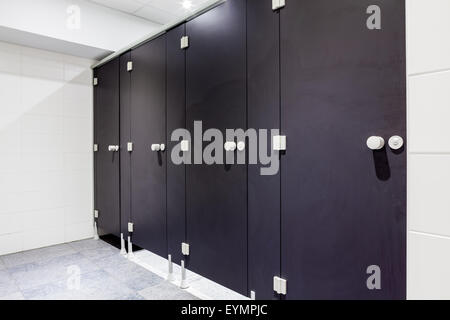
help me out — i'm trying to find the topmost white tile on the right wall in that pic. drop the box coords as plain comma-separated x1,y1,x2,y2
407,0,450,74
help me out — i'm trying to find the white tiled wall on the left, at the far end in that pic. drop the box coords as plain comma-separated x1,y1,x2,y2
0,42,93,255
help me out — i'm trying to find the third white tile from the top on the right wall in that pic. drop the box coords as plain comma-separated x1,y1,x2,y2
408,155,450,236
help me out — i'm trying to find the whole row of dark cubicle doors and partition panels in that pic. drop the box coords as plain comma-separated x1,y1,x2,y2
95,0,406,299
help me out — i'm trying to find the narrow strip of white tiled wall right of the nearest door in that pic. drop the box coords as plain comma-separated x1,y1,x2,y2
407,0,450,299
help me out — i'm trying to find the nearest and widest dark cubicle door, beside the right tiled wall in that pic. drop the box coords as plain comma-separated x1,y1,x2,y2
281,0,406,299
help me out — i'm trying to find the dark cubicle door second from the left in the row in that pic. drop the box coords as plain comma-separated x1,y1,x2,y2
131,36,167,257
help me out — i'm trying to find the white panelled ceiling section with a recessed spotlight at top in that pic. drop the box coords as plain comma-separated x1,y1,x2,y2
89,0,213,24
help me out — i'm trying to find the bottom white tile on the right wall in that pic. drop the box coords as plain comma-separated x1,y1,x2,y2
408,232,450,300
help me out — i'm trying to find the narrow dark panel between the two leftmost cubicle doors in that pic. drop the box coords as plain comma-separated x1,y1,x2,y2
120,52,132,239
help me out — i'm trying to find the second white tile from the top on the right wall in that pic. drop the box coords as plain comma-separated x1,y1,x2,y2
408,72,450,152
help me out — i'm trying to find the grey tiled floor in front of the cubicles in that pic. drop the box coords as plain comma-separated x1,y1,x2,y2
0,240,199,300
